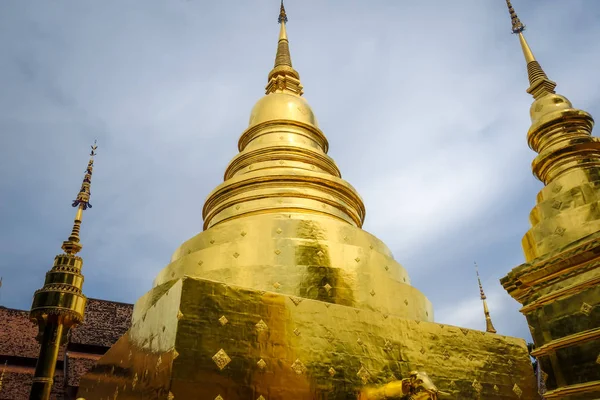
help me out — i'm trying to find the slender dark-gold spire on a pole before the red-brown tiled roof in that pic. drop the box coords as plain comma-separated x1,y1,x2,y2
29,141,98,400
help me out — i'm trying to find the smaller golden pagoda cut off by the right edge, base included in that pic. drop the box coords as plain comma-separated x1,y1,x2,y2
501,0,600,400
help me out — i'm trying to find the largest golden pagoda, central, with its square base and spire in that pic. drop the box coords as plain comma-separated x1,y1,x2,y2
78,4,537,400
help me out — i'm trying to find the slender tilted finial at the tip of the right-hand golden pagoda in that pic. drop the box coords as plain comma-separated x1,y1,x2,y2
506,0,556,100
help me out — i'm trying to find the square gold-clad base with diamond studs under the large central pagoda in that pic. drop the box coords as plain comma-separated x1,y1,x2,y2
79,277,536,400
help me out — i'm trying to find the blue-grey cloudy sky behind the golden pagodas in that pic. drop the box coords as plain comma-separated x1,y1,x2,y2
0,0,600,338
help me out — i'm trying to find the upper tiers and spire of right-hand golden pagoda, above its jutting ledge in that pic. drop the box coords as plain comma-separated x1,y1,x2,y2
507,0,600,261
